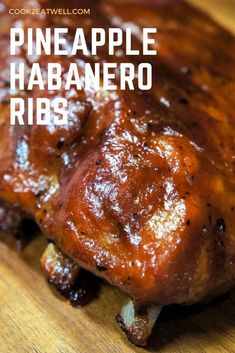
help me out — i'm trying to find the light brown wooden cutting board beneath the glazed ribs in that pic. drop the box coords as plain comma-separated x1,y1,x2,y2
0,0,235,353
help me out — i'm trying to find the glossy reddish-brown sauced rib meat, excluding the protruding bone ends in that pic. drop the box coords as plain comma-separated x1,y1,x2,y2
0,0,235,324
